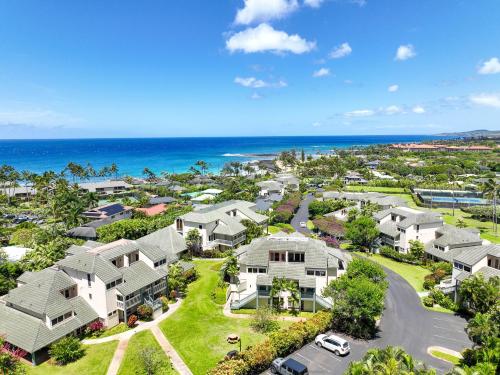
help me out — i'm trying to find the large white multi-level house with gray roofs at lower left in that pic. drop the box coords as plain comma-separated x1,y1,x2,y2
0,228,186,364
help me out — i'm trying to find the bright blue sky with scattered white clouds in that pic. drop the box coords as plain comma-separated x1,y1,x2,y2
0,0,500,138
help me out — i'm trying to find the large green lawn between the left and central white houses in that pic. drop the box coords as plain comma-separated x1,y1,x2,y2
160,260,289,375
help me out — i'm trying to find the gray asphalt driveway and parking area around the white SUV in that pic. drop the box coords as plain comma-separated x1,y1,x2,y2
264,269,472,375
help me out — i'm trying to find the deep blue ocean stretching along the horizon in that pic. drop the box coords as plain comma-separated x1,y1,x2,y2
0,135,446,176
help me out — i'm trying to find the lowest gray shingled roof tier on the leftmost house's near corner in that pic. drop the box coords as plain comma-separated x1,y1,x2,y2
0,297,99,353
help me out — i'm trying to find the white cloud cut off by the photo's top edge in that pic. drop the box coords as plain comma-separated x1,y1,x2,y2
234,0,299,25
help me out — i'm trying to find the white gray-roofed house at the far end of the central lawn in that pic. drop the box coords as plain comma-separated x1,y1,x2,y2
173,200,268,250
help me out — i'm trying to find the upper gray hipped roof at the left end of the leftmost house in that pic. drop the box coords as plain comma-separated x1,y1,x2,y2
5,268,76,318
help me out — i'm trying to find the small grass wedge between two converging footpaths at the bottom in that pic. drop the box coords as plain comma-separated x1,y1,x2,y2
118,330,177,375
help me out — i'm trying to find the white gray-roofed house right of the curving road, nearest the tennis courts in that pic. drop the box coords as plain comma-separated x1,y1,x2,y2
373,207,443,253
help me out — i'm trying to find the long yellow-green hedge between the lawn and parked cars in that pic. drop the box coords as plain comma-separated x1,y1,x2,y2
208,311,332,375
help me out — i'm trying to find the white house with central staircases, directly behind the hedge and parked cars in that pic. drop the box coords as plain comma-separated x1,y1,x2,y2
229,232,351,311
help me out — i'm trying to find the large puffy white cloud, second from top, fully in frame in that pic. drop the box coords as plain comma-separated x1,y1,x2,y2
226,23,316,54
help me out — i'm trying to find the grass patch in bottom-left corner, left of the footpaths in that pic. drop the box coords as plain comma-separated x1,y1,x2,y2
26,341,118,375
